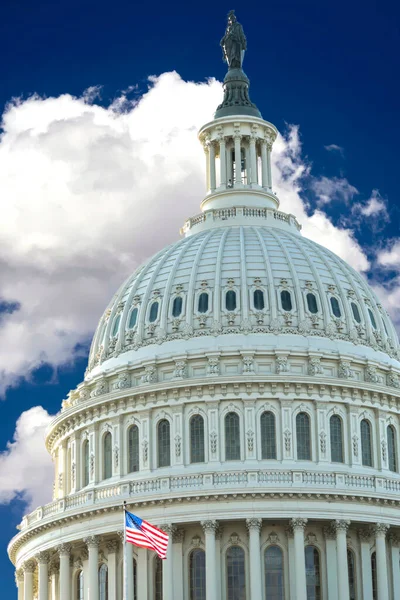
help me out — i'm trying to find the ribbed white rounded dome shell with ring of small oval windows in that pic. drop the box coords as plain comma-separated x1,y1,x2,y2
87,211,399,375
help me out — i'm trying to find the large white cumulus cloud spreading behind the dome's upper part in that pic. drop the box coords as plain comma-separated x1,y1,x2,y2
0,73,376,394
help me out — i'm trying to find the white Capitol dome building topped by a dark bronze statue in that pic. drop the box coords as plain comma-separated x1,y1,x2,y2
9,13,400,600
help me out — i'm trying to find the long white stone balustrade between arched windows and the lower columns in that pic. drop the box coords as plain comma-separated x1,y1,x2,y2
20,470,400,531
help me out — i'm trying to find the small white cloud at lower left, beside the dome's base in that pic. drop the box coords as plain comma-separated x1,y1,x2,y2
0,406,54,508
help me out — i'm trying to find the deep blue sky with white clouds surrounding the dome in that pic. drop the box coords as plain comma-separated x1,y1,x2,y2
0,0,400,598
